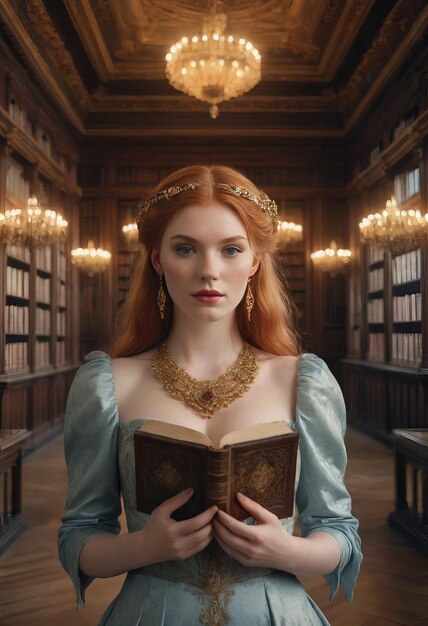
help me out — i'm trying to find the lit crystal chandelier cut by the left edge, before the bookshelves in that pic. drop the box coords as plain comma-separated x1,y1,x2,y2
0,196,68,248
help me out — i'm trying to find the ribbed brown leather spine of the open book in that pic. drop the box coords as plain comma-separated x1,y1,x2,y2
206,448,231,511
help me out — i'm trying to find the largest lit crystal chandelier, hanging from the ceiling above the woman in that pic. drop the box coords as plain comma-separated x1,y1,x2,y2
165,2,261,119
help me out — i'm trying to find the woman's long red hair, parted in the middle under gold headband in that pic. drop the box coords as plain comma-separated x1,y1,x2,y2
112,165,300,357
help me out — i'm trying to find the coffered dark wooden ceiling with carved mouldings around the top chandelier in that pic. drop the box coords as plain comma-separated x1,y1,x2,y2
0,0,428,137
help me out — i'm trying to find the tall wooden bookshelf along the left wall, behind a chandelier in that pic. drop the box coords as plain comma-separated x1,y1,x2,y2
0,57,81,454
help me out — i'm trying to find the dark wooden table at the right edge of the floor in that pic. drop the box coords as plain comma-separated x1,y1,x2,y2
389,428,428,556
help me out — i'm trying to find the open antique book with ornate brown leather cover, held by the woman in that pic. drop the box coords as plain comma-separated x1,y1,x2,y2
134,420,298,520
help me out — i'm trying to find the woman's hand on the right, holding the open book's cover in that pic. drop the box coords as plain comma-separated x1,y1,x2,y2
213,494,295,570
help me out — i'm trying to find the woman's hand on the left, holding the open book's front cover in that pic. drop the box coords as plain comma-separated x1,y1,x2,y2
140,489,218,563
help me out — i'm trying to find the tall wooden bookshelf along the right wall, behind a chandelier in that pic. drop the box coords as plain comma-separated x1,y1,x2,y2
343,137,428,444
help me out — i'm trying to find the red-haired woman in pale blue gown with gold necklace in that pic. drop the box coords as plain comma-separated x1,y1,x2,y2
59,166,361,626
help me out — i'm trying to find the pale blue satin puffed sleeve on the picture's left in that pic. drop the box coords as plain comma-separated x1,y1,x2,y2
58,352,121,607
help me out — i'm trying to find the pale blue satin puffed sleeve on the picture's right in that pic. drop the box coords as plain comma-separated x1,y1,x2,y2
295,354,362,600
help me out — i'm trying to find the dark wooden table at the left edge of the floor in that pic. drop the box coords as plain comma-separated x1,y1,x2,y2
0,429,30,555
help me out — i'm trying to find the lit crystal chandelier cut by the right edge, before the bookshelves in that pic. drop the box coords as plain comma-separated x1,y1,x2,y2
359,198,428,252
